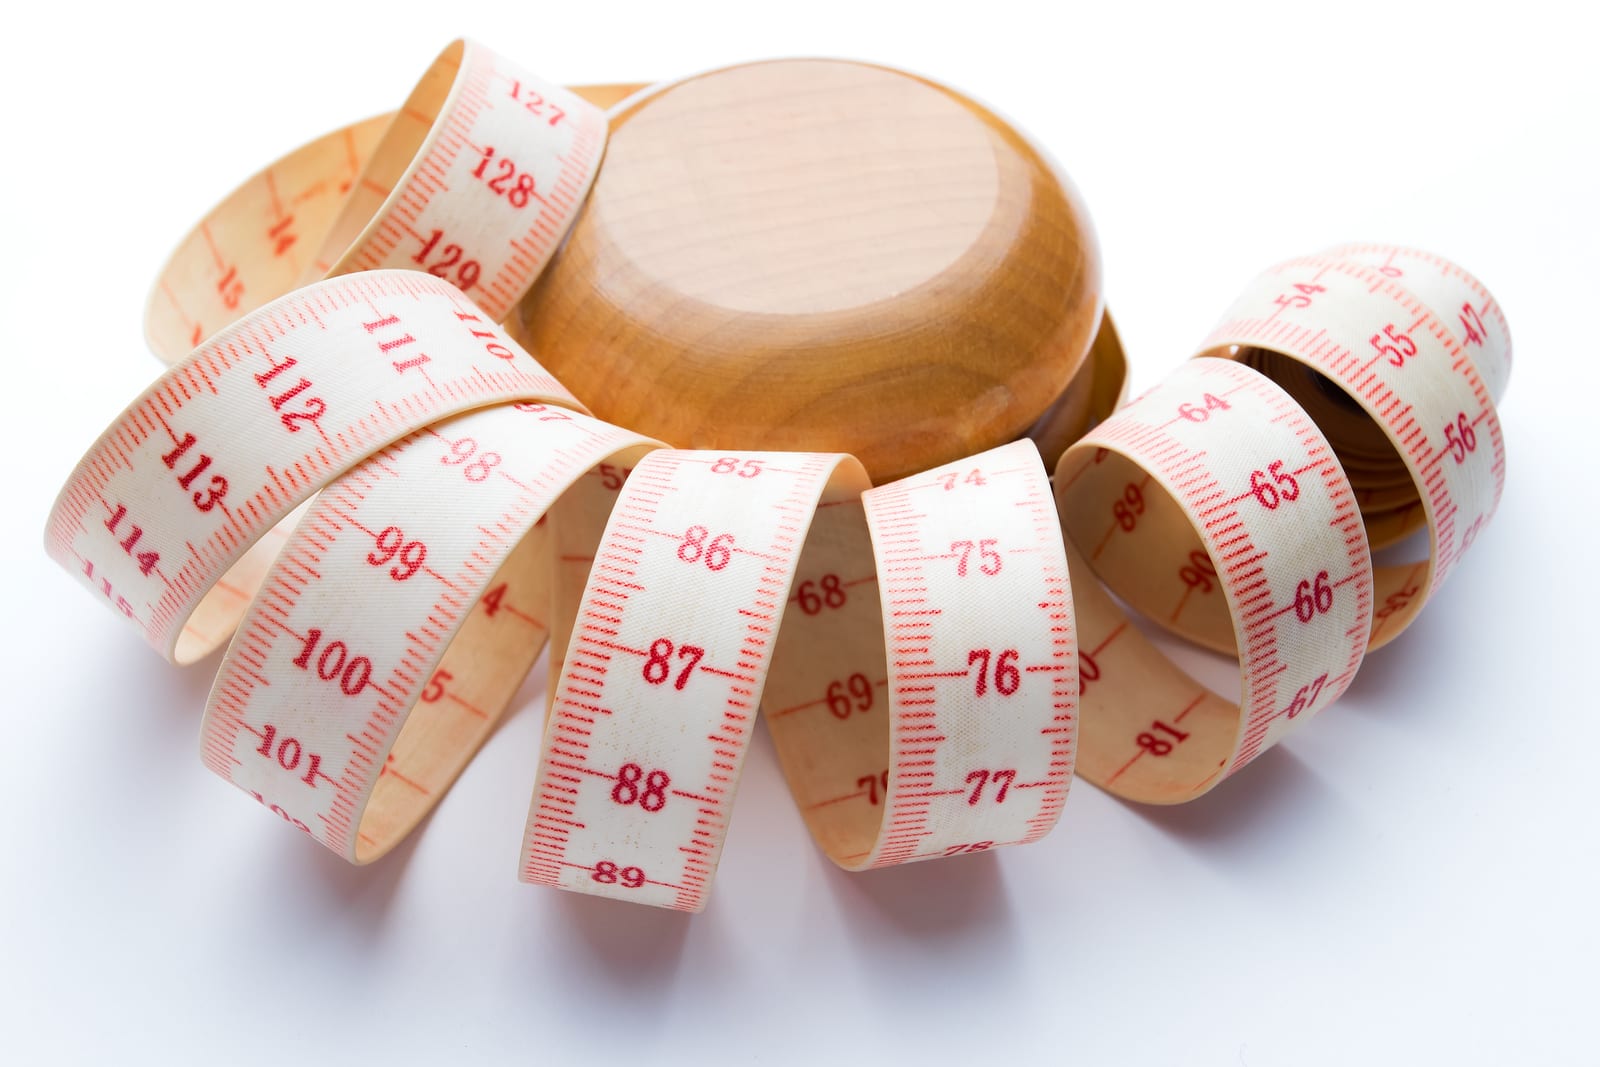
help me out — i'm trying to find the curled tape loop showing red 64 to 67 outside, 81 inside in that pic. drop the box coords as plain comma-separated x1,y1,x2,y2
1056,360,1373,803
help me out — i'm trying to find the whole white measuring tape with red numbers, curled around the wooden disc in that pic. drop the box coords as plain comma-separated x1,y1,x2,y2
46,45,1510,910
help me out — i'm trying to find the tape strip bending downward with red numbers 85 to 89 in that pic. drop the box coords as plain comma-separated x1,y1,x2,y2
522,451,867,910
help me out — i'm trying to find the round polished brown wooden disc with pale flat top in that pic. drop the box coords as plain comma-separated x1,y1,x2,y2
507,59,1102,483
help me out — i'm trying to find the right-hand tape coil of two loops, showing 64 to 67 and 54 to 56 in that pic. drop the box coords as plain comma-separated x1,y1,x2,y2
1056,252,1510,803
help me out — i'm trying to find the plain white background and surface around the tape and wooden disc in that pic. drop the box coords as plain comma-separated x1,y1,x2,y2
0,0,1600,1067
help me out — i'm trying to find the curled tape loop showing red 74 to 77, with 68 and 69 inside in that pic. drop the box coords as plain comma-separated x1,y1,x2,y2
768,442,1078,870
